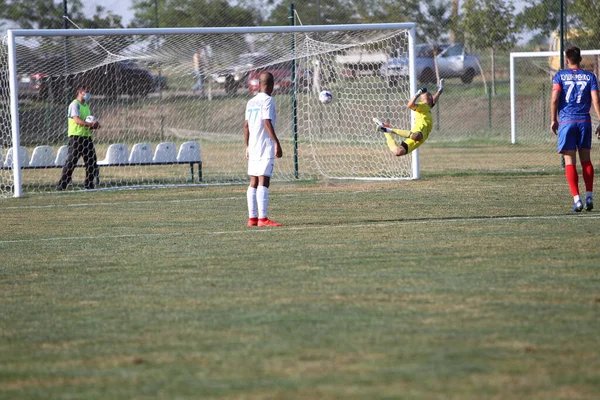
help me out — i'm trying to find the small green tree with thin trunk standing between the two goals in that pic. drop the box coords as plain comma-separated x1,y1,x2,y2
461,0,518,95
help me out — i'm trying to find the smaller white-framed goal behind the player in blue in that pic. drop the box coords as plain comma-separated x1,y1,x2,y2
510,50,600,171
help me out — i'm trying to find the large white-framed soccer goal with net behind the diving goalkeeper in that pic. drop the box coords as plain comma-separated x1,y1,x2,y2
0,23,419,197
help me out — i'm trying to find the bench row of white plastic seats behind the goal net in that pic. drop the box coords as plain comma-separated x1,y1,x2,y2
0,141,202,182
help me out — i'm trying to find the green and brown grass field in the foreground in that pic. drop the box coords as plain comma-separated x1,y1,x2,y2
0,173,600,400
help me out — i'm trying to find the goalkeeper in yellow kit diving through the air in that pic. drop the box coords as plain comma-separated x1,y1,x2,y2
373,79,444,157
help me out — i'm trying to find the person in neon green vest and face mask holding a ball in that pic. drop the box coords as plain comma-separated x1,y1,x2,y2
56,86,100,190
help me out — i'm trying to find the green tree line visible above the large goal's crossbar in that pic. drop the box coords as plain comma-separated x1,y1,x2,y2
0,0,600,49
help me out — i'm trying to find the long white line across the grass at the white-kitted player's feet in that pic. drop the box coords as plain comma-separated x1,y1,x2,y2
0,213,600,245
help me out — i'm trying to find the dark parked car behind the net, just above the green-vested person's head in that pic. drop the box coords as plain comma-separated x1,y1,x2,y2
39,60,157,99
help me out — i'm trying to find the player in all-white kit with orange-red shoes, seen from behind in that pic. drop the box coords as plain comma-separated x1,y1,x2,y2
244,72,283,226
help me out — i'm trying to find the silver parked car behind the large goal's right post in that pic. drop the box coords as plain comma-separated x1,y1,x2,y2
381,43,479,86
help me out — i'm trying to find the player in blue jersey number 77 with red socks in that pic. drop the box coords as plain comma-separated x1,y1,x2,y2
550,46,600,212
